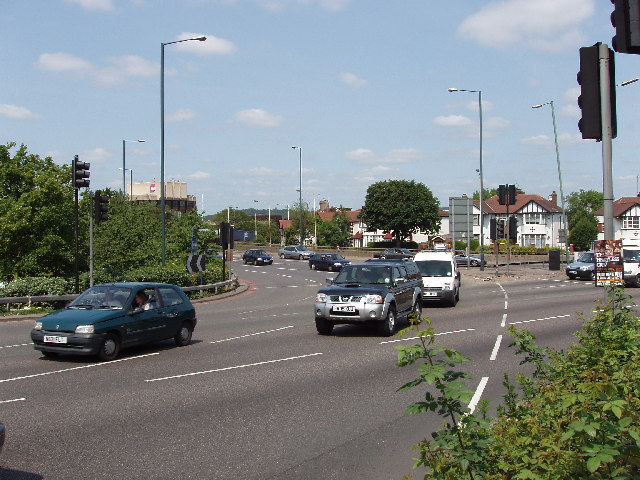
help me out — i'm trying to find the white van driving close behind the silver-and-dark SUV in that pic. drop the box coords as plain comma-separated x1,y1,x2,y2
413,250,460,307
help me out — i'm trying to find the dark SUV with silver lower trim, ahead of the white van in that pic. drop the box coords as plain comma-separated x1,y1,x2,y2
315,259,422,336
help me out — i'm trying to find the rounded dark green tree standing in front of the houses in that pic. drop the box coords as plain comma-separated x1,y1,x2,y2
360,180,440,246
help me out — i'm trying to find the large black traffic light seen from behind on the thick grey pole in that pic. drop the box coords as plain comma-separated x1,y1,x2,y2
577,43,617,141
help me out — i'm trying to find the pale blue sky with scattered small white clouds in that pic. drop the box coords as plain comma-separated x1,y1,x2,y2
0,0,640,214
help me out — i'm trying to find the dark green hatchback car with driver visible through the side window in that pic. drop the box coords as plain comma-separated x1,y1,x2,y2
31,283,197,361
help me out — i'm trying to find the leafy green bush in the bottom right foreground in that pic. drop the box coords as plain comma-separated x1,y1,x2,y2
398,288,640,480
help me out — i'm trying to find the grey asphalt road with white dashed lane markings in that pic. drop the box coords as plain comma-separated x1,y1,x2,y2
0,259,638,480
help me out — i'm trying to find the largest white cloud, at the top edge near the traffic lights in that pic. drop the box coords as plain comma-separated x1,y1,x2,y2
458,0,595,51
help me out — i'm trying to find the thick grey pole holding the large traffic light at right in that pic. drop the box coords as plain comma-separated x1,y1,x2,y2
598,44,614,240
